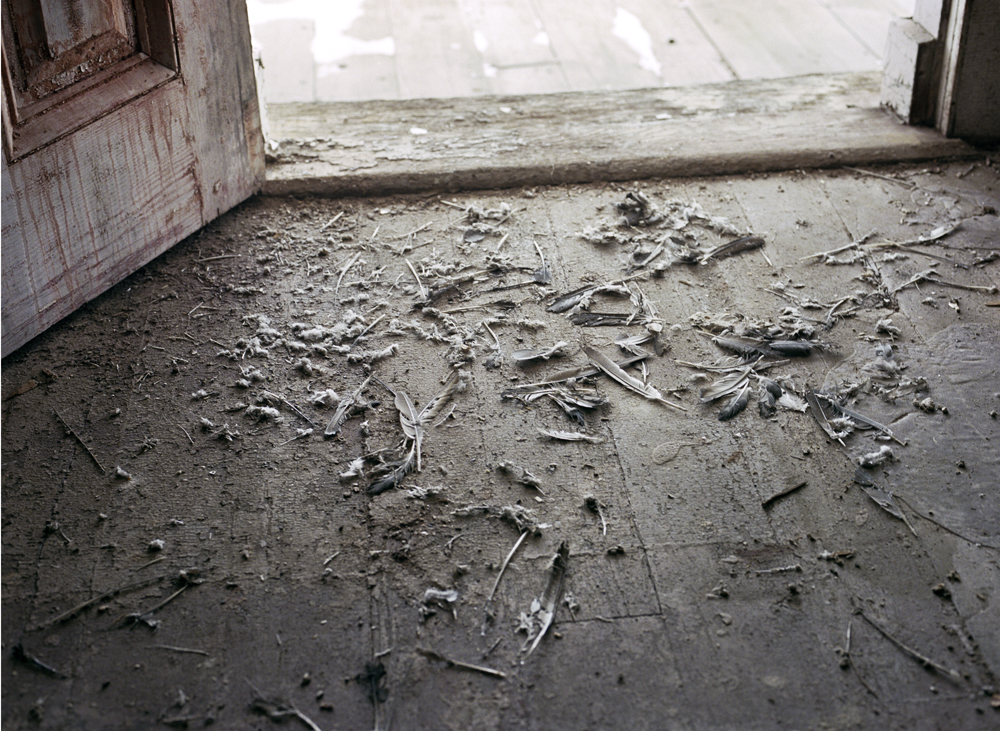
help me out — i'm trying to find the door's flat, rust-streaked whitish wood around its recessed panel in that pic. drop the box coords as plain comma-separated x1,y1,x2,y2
2,0,263,356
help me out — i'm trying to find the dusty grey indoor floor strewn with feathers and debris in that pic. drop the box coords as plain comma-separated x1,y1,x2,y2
2,160,1000,729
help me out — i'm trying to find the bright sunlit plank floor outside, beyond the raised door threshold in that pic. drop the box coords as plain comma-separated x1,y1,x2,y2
247,0,913,104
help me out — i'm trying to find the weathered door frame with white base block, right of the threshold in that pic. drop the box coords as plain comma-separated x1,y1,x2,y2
882,0,1000,142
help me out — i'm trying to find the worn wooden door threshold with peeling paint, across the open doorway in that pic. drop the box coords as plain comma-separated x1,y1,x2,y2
264,72,982,196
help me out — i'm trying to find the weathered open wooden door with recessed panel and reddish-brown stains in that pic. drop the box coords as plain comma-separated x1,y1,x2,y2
0,0,264,356
